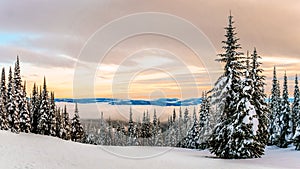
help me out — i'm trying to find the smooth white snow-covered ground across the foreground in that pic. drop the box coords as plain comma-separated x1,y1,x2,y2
0,131,300,169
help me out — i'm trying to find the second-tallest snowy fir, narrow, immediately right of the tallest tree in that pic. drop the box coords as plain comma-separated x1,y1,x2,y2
249,48,269,147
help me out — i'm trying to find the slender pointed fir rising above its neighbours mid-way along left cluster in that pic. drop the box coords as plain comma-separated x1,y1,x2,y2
37,77,50,135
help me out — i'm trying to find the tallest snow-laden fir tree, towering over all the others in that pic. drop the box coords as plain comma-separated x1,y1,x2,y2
209,12,243,158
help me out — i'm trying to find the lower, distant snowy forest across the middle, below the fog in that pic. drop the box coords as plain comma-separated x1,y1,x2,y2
85,94,211,149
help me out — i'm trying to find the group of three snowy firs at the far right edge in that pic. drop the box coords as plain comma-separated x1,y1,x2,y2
268,66,300,150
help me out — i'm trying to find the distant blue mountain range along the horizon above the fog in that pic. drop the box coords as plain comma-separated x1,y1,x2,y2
55,98,202,106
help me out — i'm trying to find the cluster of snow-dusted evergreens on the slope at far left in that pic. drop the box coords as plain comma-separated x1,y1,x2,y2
0,56,84,141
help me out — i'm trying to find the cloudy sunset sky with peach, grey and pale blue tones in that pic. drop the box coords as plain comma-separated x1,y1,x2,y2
0,0,300,99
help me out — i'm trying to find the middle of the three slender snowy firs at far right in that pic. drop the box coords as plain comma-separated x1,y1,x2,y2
276,73,293,148
